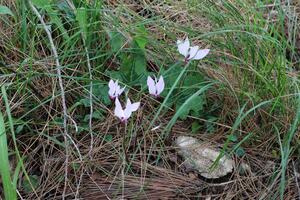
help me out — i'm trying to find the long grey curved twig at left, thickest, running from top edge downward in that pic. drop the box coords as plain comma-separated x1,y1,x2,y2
29,1,69,199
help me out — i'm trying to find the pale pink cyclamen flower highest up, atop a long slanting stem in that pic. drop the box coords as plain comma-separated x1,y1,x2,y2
177,37,210,62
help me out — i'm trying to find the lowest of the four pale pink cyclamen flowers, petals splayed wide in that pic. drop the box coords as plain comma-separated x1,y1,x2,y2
115,98,140,123
